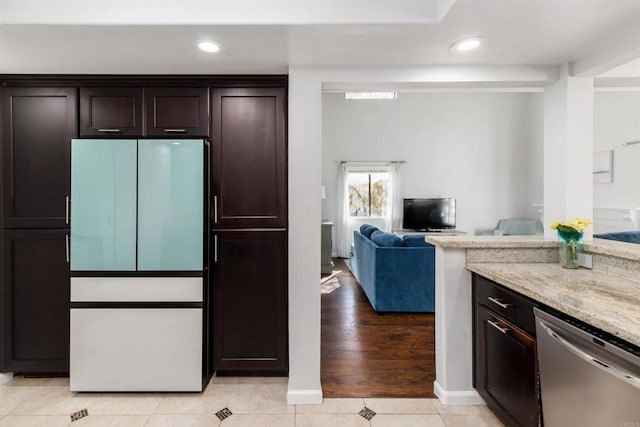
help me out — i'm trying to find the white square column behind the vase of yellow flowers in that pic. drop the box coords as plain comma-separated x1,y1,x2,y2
544,71,593,238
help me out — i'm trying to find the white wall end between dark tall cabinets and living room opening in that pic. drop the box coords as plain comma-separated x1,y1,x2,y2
287,68,322,404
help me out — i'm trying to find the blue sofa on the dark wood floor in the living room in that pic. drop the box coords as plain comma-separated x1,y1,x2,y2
350,225,435,313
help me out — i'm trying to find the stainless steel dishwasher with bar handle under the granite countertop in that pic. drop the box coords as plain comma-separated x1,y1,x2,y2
534,308,640,427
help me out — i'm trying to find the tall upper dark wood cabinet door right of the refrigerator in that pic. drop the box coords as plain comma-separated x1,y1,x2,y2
211,88,287,227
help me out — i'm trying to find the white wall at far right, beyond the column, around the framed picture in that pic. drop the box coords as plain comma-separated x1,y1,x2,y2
593,91,640,208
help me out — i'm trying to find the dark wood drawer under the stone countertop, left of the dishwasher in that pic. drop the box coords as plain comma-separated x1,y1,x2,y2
473,274,539,336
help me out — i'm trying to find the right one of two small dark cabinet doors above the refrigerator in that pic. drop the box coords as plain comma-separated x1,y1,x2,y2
145,87,209,136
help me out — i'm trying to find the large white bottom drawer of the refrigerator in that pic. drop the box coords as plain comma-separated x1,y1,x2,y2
70,308,202,391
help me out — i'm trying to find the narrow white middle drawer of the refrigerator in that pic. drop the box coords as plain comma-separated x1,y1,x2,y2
71,277,203,302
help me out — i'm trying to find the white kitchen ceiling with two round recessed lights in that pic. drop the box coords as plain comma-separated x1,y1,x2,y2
0,0,640,77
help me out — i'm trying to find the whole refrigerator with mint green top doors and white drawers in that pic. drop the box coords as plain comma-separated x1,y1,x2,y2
70,139,212,391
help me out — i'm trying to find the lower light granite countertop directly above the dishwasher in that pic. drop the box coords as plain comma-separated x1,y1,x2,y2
466,263,640,346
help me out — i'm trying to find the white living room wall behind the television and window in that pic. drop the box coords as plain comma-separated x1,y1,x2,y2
322,92,544,241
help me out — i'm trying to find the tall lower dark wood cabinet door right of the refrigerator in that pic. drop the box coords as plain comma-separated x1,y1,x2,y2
211,231,288,375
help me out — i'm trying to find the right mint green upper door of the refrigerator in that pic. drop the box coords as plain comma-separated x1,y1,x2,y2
138,140,204,271
